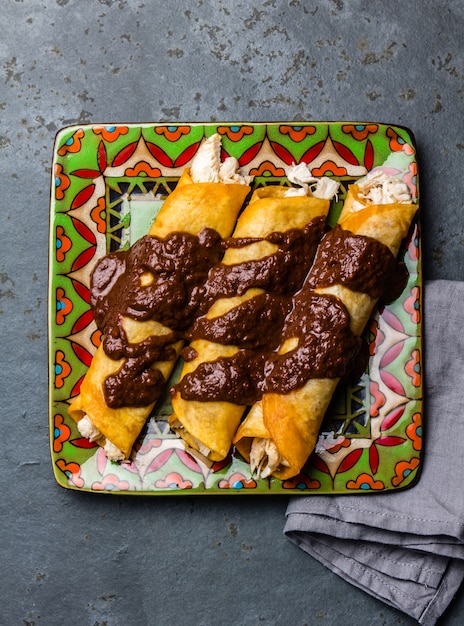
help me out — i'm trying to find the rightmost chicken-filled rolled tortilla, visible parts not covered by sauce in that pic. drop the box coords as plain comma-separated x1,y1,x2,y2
234,171,418,479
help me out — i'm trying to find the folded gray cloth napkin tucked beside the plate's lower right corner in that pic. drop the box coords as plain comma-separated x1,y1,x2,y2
285,280,464,626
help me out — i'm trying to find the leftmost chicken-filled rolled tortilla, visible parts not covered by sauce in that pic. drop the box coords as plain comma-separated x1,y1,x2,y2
69,135,251,460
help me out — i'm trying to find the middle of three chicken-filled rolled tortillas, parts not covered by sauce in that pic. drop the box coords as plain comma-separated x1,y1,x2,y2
169,171,338,461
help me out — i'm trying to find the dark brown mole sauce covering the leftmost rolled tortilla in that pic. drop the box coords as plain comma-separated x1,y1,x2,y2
91,229,223,408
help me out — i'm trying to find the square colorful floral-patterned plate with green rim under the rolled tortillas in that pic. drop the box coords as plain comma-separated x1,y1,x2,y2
49,122,423,495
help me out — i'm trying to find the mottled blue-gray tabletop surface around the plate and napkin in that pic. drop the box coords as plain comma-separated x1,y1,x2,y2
0,0,464,626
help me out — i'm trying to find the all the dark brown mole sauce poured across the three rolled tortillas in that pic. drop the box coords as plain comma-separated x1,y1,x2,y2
91,218,406,408
